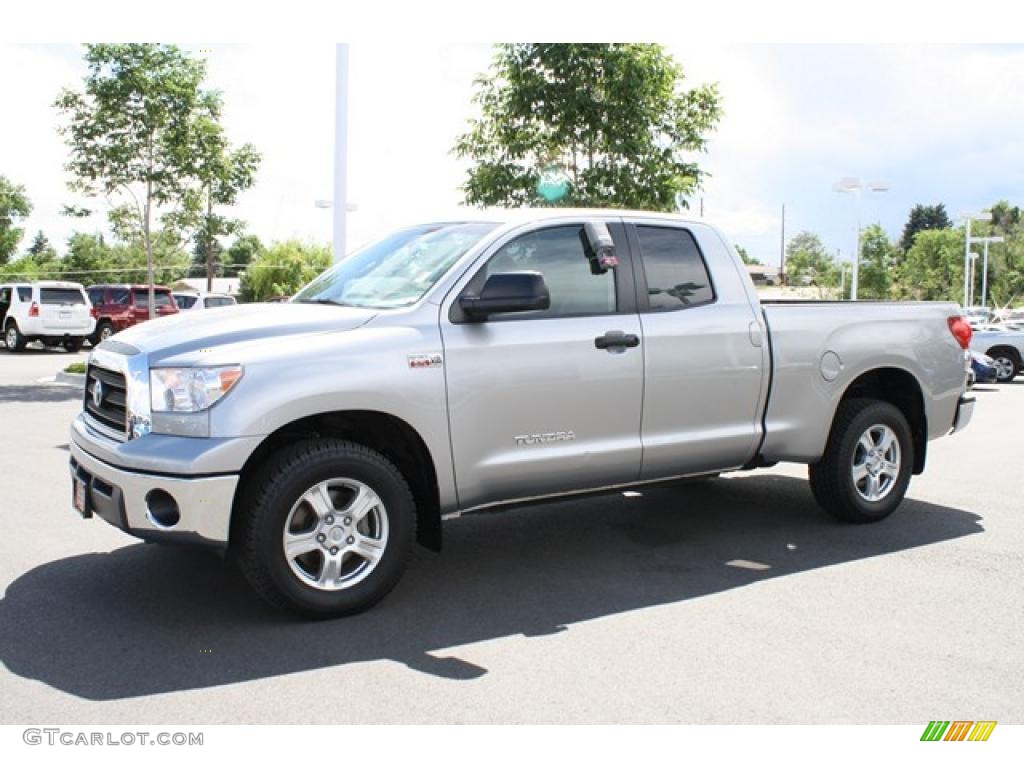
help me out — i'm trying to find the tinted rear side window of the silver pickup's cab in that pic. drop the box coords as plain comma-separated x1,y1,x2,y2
636,224,715,312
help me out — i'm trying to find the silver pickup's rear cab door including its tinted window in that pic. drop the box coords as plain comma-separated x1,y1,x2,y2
629,220,768,479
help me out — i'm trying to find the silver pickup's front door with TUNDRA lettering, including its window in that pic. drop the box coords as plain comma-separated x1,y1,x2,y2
441,222,643,509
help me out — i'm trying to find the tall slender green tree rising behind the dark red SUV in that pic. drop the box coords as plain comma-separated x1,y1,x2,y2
55,43,206,313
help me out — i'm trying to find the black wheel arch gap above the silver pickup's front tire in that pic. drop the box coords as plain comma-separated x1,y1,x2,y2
234,411,441,552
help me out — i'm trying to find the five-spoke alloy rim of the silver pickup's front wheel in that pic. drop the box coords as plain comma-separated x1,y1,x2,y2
282,477,388,592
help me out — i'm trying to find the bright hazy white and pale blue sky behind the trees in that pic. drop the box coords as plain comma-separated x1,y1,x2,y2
0,42,1024,263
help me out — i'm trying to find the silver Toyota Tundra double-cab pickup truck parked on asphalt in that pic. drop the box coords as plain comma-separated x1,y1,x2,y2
71,209,974,616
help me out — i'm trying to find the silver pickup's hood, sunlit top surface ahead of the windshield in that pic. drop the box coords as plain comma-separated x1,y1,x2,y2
109,303,377,361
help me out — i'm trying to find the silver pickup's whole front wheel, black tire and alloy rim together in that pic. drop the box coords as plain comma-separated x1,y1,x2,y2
231,438,416,618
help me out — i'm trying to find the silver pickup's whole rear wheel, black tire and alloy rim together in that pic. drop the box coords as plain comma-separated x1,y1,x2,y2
809,397,913,523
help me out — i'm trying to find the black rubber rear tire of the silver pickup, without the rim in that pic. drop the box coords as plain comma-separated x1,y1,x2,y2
808,397,913,523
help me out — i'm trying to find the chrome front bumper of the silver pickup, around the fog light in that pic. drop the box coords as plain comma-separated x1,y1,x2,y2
71,440,239,549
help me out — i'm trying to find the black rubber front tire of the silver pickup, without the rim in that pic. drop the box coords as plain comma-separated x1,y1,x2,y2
230,438,416,618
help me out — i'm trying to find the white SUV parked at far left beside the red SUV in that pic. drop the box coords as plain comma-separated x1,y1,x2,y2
0,281,96,352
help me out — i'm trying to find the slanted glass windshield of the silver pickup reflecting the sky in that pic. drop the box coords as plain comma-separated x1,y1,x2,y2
292,222,498,309
